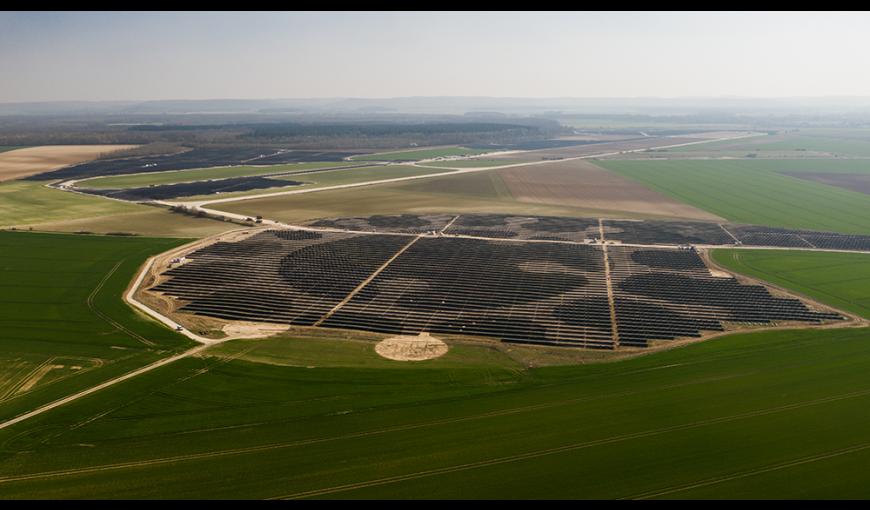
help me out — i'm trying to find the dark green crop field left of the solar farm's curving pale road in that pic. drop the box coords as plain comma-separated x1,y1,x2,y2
0,232,189,422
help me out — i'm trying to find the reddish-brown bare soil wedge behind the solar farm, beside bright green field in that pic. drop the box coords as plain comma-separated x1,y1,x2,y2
498,160,724,221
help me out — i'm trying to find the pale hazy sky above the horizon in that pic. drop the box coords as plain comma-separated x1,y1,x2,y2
0,12,870,102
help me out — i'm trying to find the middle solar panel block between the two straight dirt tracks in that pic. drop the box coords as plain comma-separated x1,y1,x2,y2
324,238,612,348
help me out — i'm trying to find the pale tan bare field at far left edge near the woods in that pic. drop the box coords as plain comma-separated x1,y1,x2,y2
0,145,138,182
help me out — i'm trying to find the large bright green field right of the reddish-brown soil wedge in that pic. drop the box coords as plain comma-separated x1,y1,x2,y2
597,160,870,234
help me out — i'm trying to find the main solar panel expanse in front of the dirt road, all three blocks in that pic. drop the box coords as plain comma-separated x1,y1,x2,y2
154,228,840,349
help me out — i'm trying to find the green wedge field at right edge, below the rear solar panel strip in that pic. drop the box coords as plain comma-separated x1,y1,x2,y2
712,250,870,319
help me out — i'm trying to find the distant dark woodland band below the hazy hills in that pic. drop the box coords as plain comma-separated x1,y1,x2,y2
0,116,568,150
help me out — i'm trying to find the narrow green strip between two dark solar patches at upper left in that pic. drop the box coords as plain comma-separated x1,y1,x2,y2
77,161,352,189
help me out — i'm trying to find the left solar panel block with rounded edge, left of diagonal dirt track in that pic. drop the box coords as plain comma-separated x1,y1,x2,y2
154,231,409,326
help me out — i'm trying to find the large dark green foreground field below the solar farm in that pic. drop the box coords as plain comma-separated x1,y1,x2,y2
0,329,870,499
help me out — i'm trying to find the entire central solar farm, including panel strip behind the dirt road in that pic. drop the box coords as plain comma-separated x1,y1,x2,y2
150,214,856,350
